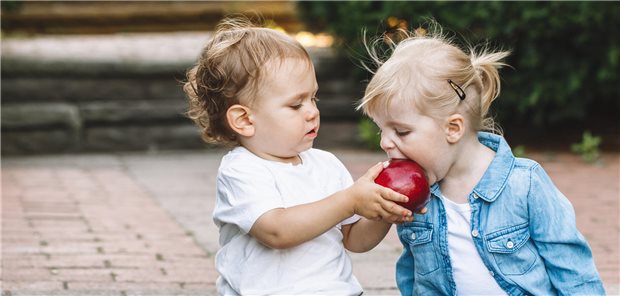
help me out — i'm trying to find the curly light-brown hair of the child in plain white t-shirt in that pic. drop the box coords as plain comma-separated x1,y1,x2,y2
183,17,311,146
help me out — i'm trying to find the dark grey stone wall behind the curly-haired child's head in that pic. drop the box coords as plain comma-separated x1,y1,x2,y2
1,33,362,155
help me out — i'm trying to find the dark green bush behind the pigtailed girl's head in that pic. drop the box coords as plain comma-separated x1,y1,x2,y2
298,1,620,128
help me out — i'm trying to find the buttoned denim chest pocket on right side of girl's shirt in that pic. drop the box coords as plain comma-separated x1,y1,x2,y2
486,223,537,275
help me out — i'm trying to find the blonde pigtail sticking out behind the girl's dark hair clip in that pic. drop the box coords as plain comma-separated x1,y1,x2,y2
470,48,510,133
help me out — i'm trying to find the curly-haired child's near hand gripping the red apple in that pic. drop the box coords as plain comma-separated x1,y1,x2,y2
347,163,413,223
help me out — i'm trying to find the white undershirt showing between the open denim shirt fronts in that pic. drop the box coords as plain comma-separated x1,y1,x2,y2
440,196,506,295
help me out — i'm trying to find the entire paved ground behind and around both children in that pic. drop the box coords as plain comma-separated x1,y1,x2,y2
0,150,620,296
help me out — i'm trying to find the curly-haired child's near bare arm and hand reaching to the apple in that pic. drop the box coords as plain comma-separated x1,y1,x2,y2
250,163,412,249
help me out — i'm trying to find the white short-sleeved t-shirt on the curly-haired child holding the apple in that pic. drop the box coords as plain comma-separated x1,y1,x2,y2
213,147,362,295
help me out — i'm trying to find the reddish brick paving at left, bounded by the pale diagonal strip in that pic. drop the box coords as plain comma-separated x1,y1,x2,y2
2,156,216,296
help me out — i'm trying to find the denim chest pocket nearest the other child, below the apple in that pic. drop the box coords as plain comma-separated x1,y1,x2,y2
399,221,439,275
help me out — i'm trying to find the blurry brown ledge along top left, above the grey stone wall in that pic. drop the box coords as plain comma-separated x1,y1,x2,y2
1,0,303,34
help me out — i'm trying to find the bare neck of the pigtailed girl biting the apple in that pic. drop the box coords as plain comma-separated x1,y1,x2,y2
440,137,495,203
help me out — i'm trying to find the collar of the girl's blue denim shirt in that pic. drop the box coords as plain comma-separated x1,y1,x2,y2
431,132,515,202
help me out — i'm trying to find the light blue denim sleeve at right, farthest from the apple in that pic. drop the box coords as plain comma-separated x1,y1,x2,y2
528,164,605,295
